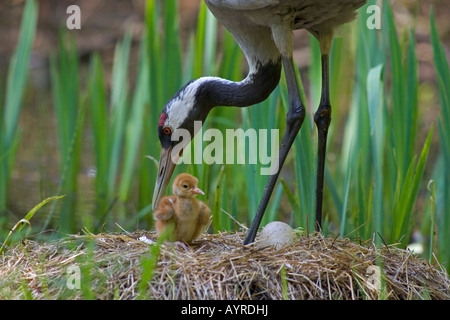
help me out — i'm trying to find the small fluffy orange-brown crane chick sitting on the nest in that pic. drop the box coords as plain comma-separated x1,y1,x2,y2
153,173,211,244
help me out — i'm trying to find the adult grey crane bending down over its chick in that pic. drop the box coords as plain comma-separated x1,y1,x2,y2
153,0,366,244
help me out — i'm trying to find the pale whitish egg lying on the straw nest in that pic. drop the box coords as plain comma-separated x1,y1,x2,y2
257,221,297,249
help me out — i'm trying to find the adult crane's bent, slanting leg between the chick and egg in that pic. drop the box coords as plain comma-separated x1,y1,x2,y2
243,56,305,245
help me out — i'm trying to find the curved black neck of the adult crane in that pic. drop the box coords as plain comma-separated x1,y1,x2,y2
196,59,282,108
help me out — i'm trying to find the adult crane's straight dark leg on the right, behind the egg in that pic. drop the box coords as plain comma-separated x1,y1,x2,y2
314,53,331,232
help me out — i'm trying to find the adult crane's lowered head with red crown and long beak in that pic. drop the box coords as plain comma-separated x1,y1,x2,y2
152,80,211,210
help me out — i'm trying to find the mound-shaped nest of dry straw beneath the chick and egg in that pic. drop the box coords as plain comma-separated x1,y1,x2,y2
0,231,450,300
